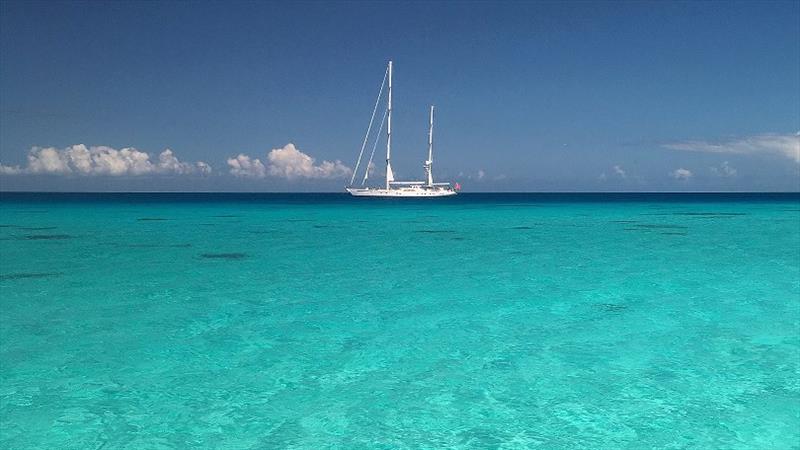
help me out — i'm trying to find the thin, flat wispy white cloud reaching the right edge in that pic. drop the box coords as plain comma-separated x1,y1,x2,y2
664,132,800,163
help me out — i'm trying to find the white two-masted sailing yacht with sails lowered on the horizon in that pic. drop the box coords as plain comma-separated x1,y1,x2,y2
345,61,459,197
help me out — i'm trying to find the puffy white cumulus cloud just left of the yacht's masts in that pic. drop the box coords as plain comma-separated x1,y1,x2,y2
228,143,352,180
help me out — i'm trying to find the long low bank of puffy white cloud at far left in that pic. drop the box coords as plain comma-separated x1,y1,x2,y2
0,144,211,176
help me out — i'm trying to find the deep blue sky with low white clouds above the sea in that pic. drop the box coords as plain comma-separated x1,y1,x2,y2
0,0,800,192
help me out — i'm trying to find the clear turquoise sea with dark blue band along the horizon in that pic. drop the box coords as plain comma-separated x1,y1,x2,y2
0,193,800,449
